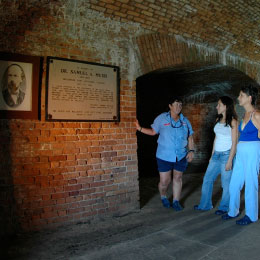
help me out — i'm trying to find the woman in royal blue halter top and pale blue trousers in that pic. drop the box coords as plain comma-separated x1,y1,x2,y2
222,85,260,225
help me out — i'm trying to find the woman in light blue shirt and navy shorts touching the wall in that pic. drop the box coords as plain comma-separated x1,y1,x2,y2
136,97,194,211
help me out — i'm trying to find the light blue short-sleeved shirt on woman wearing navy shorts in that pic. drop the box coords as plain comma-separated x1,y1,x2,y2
151,112,193,162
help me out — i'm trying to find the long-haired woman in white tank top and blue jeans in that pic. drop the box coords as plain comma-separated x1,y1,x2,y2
194,96,238,215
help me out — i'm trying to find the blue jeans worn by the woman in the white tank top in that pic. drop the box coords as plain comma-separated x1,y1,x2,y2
198,150,232,211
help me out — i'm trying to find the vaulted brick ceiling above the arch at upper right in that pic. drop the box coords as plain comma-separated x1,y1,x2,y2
90,0,260,61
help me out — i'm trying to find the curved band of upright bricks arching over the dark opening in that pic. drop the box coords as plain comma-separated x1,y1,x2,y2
136,33,260,83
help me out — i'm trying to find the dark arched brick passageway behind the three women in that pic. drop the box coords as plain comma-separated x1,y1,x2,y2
136,63,256,206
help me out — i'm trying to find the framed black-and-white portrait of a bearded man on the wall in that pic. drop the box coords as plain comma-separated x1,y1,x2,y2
0,52,41,119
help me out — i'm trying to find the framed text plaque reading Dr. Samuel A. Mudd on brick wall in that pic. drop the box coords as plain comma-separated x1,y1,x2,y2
46,56,120,122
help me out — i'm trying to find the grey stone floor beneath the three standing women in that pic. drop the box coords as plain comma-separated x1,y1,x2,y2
1,174,260,260
